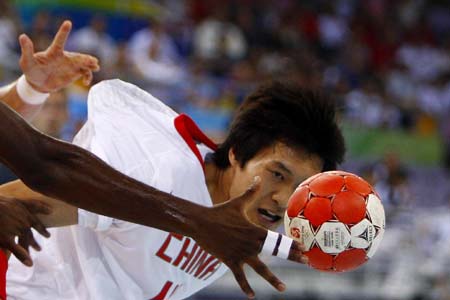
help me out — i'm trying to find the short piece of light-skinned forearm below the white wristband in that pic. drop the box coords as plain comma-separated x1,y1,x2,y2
0,81,41,120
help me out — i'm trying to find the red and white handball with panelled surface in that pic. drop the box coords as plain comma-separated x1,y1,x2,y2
284,171,385,272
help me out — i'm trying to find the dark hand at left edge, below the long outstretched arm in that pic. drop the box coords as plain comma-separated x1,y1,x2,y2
0,196,51,266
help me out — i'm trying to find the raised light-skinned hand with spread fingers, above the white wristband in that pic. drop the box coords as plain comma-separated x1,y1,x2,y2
19,21,100,93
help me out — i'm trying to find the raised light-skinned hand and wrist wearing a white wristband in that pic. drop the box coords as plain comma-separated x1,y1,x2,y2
0,21,99,119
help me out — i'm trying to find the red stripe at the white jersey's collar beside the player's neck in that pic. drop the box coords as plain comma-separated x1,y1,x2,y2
174,114,217,169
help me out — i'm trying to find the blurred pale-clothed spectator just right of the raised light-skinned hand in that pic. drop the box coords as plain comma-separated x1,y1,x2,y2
67,15,118,78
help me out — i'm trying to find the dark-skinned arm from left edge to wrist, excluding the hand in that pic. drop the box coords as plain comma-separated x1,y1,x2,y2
0,104,205,236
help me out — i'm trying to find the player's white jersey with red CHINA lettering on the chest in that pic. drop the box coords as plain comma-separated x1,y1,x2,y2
7,80,227,300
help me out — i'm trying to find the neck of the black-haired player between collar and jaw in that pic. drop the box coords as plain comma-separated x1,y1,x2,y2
205,161,233,205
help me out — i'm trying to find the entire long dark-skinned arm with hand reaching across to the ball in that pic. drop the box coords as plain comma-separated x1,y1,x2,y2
0,103,303,297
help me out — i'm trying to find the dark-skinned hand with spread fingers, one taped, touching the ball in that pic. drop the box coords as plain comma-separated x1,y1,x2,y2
193,181,307,298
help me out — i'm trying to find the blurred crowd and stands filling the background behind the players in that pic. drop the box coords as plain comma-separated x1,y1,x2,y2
0,0,450,300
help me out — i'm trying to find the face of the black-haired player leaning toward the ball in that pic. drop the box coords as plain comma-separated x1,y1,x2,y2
230,143,322,229
